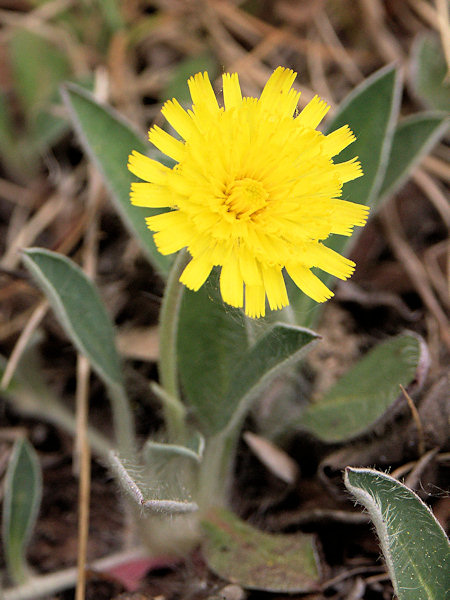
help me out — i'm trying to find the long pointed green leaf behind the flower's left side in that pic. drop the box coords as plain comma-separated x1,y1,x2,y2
62,84,171,277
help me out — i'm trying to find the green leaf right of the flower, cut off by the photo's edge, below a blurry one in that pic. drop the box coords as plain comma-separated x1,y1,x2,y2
379,113,449,198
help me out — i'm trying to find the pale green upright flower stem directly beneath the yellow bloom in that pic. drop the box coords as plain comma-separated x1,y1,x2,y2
159,250,188,442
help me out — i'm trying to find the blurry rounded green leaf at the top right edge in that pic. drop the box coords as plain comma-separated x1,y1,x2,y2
411,34,450,112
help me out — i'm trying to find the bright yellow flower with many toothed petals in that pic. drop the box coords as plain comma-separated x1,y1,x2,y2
128,67,368,317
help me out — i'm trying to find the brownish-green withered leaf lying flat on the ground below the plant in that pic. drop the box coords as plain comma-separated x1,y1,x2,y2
202,509,319,593
